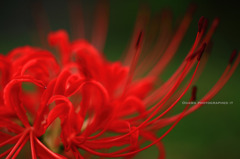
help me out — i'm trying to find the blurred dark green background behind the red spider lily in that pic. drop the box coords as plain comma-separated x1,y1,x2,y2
0,0,240,159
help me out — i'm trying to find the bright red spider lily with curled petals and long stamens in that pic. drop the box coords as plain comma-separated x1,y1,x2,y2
0,3,240,159
